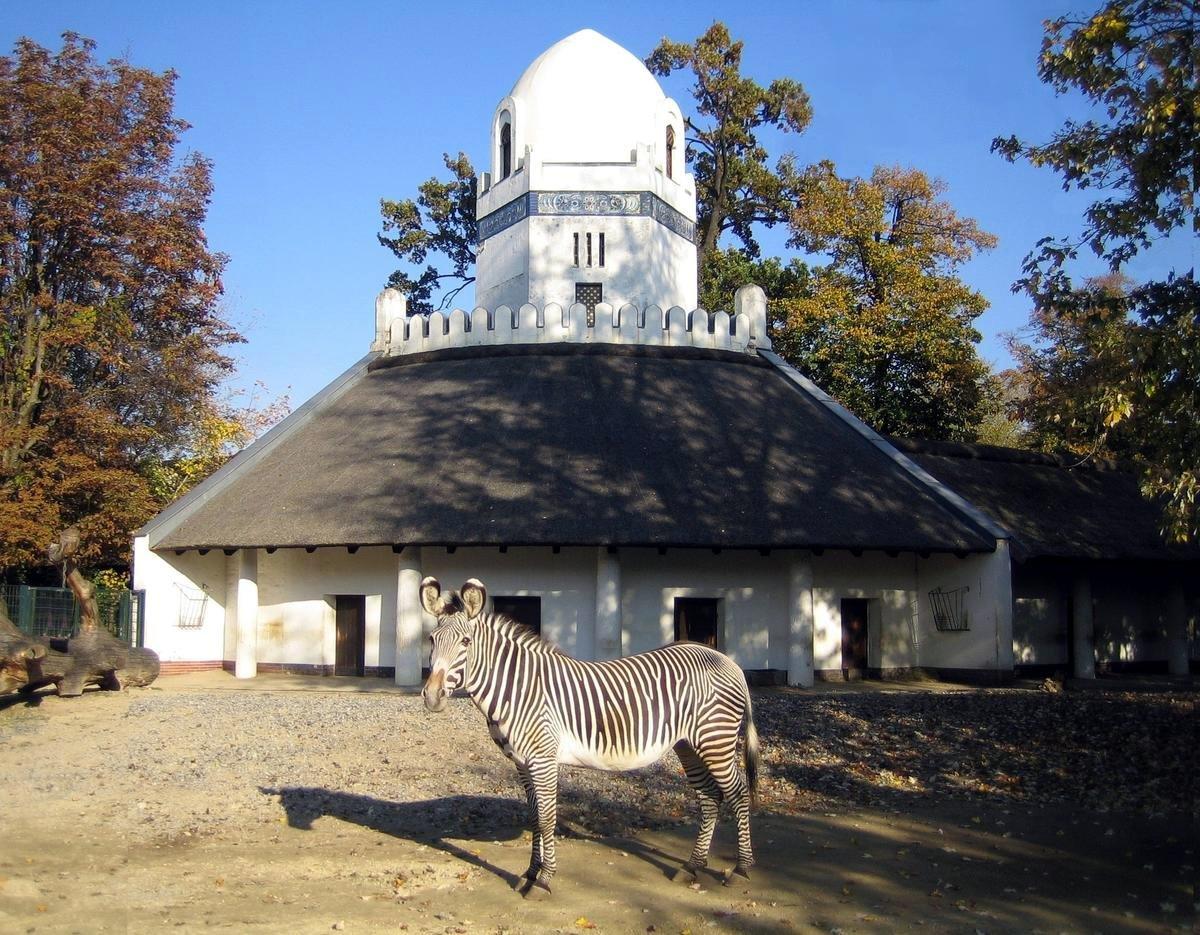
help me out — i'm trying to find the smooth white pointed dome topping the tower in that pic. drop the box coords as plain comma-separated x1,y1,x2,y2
502,29,677,162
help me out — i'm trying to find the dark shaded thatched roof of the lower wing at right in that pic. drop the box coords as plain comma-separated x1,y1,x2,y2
889,438,1200,562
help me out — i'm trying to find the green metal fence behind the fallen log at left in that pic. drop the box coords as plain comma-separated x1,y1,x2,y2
0,583,145,646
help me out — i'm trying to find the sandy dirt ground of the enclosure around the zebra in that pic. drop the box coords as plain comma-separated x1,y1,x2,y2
0,673,1196,933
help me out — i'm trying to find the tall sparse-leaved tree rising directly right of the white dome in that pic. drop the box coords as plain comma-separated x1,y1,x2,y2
646,23,812,275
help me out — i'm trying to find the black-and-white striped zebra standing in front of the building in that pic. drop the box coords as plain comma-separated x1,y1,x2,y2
420,577,758,899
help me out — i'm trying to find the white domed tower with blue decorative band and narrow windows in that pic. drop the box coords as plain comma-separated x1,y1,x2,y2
475,29,696,314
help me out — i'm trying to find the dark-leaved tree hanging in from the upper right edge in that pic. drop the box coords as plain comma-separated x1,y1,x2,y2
992,0,1200,541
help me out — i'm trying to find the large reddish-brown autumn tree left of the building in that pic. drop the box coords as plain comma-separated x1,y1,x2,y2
0,32,241,571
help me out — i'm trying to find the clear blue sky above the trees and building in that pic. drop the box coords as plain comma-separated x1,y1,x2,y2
7,0,1190,406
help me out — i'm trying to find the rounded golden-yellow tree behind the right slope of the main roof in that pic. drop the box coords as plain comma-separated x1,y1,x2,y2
773,162,996,438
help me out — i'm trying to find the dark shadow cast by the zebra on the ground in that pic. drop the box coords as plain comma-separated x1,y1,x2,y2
259,786,679,887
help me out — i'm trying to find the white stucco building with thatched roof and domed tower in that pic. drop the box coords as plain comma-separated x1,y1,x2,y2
134,30,1194,685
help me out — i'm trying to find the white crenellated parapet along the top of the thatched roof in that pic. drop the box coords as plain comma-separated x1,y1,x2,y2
371,286,770,356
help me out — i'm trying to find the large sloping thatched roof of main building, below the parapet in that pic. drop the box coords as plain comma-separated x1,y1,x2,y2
144,344,995,552
